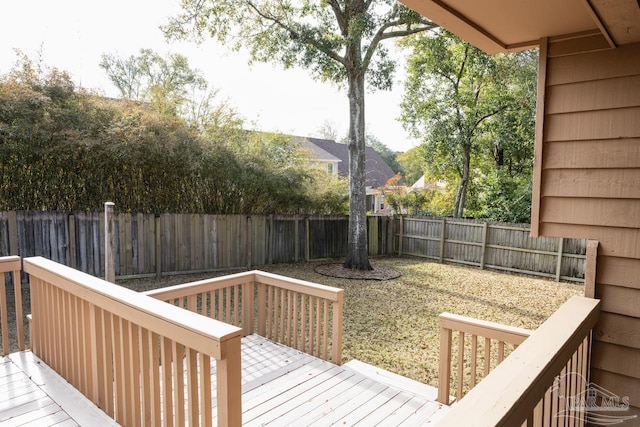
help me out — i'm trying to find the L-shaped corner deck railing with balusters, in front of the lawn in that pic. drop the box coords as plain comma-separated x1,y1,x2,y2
145,271,344,365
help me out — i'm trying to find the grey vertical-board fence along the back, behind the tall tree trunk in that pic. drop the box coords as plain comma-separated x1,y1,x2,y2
0,213,393,279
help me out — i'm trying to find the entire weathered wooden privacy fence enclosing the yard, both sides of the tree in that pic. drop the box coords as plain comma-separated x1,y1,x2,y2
0,206,586,282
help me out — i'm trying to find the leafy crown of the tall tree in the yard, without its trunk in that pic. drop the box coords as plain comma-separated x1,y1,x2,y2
163,0,433,89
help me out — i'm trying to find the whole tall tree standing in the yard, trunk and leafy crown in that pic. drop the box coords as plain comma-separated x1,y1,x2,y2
164,0,435,270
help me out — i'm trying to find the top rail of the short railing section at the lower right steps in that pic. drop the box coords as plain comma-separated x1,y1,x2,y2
438,312,533,345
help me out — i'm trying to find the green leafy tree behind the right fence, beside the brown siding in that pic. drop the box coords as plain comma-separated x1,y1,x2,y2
402,31,536,217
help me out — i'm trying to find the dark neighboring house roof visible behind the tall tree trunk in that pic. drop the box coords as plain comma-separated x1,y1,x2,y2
306,138,395,188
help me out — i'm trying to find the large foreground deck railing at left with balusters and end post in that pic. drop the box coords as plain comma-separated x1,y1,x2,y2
24,257,242,426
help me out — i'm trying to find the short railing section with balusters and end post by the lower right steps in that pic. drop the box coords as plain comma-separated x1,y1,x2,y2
438,313,532,405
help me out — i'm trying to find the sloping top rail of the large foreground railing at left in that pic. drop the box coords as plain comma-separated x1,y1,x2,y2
24,257,242,359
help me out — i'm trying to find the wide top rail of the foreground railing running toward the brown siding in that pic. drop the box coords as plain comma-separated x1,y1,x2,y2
439,296,600,426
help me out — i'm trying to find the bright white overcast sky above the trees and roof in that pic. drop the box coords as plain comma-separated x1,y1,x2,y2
0,0,416,151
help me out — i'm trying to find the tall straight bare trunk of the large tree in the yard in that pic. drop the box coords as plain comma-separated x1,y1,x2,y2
344,64,372,270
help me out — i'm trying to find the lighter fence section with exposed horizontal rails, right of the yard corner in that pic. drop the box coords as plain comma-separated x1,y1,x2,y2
395,217,587,282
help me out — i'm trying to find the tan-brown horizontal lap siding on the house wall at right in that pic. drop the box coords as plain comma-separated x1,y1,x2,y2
532,38,640,414
